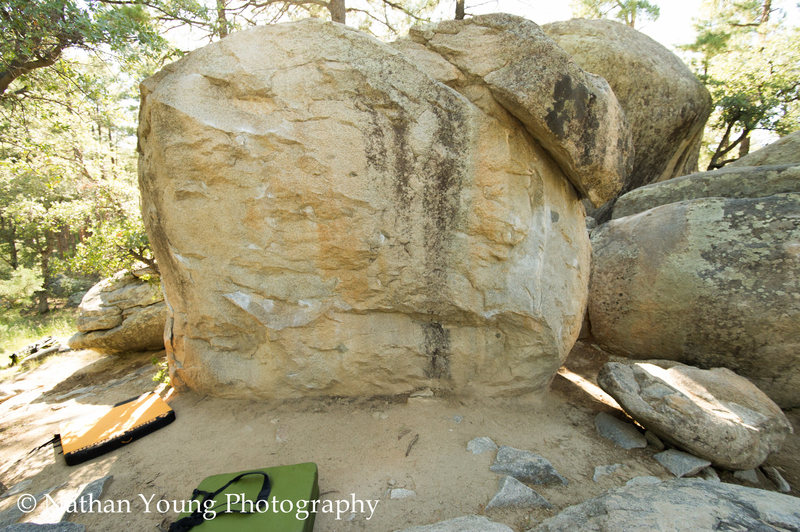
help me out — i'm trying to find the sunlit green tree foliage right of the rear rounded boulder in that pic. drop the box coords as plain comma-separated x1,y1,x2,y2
685,0,800,169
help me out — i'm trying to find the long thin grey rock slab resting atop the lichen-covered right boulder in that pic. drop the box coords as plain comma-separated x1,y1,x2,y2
612,164,800,218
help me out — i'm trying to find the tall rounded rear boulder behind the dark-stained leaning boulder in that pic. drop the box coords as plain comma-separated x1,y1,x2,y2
542,19,712,192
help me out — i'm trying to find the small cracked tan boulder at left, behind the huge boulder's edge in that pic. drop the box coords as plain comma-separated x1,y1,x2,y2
69,268,167,353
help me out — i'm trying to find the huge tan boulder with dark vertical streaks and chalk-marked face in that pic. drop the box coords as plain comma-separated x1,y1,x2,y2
139,16,590,398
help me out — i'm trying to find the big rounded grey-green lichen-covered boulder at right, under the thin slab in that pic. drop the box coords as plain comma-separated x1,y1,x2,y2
589,193,800,408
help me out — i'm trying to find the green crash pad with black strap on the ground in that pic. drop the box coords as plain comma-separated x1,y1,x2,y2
170,462,319,532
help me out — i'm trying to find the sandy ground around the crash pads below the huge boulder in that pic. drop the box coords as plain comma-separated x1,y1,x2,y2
0,343,800,532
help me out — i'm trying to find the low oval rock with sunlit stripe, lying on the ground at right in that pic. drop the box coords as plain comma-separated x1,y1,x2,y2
597,360,792,469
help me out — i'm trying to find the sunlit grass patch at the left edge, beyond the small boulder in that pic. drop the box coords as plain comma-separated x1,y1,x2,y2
0,307,78,360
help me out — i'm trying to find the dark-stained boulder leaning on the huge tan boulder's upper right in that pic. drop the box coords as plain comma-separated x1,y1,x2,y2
409,14,633,207
